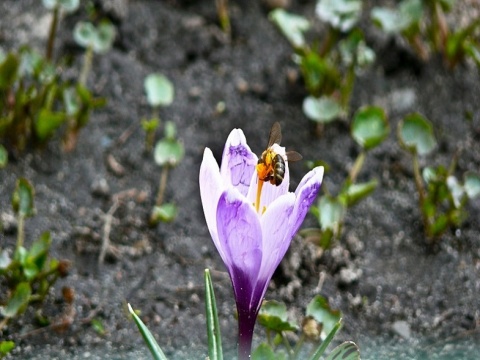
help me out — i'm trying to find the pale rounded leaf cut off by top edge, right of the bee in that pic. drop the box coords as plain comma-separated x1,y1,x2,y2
315,0,362,32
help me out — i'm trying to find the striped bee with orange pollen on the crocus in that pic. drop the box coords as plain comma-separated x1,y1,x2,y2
257,122,302,186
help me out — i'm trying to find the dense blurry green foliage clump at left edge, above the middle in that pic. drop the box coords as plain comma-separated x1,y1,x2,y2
0,47,104,155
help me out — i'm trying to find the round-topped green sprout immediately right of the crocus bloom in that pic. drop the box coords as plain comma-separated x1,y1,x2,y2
300,106,390,249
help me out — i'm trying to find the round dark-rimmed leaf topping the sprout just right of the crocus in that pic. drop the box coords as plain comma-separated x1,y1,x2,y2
351,106,390,150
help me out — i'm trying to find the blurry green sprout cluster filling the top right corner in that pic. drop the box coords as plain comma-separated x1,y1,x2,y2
371,0,480,68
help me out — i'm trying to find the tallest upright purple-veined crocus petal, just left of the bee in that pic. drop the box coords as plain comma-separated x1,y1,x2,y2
220,129,258,196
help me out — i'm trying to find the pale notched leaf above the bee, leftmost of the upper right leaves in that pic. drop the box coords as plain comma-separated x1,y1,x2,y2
268,8,310,48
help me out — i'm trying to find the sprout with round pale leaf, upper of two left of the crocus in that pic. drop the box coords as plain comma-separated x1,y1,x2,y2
141,73,175,153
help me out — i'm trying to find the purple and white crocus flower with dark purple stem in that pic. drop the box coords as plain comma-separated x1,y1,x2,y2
200,129,323,359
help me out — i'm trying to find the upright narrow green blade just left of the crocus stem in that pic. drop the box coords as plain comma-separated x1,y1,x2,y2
205,269,223,360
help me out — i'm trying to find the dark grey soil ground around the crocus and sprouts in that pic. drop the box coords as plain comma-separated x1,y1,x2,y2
0,0,480,359
